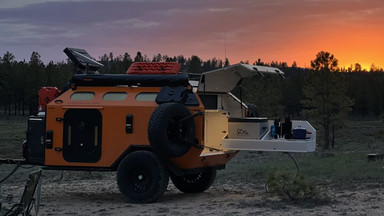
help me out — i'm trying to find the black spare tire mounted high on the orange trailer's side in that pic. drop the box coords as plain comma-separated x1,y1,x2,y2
148,103,195,158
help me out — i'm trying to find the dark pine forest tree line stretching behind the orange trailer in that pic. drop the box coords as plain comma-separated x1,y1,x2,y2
0,51,384,149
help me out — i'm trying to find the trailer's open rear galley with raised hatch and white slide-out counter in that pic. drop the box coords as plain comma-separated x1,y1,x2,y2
196,64,316,153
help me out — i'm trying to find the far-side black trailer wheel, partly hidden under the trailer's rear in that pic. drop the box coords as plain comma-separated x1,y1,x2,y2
171,169,216,193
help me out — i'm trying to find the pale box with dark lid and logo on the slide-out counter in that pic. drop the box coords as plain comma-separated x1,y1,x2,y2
228,118,268,139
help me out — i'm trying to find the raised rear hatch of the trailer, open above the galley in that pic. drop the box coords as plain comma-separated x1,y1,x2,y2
198,64,284,92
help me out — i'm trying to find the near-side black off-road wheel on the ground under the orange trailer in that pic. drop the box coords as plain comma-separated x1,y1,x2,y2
117,151,169,203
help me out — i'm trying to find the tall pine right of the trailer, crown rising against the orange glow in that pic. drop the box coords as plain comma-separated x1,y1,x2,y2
302,51,352,150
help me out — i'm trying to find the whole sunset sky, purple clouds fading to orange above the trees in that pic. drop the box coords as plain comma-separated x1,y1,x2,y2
0,0,384,69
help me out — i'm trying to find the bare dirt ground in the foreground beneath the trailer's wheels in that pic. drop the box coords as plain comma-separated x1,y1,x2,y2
1,178,384,216
